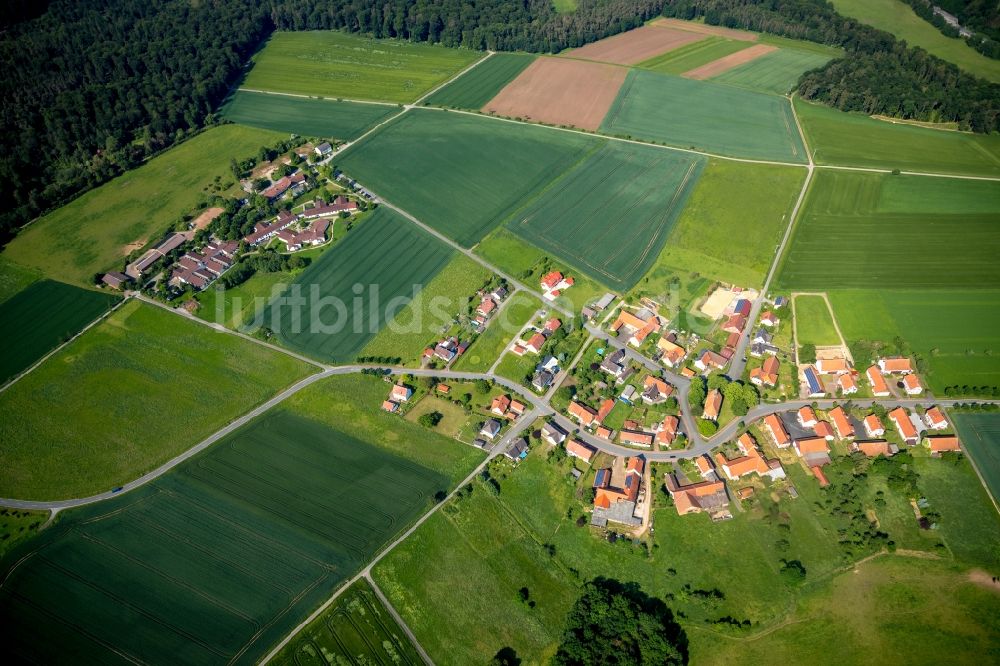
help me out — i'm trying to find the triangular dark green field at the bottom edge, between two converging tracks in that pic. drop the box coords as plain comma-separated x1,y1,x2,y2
270,580,423,666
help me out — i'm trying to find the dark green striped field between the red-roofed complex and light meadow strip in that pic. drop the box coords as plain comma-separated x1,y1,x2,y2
263,207,453,362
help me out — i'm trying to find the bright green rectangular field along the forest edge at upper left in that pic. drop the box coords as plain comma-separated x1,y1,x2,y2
243,30,483,103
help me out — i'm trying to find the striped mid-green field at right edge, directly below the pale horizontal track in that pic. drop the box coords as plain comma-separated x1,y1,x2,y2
778,170,1000,290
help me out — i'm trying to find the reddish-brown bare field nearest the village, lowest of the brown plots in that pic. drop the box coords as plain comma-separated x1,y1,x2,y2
483,58,628,130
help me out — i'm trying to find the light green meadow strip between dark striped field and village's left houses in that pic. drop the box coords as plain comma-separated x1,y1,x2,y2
361,253,490,365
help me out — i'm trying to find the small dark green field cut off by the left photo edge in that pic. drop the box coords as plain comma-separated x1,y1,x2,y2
0,280,120,383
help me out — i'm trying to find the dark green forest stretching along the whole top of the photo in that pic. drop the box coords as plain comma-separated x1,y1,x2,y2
0,0,1000,253
